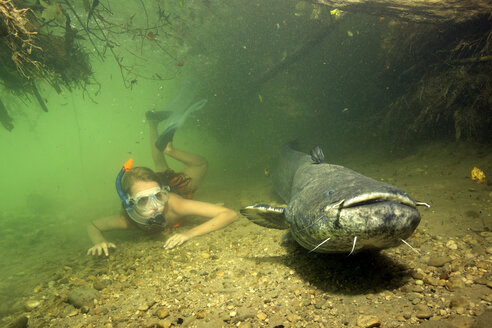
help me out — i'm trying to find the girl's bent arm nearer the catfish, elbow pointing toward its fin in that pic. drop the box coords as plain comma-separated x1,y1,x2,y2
164,195,237,249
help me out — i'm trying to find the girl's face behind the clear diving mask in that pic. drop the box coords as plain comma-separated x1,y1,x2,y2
131,181,167,216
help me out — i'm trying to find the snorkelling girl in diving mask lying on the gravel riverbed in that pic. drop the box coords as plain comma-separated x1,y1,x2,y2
87,108,237,256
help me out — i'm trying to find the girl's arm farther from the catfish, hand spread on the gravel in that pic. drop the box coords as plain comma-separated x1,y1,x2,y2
87,215,128,256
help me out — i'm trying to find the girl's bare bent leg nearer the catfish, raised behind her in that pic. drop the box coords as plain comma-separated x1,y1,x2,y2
164,142,208,191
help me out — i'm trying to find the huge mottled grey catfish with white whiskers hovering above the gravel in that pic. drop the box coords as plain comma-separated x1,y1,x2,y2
241,147,429,254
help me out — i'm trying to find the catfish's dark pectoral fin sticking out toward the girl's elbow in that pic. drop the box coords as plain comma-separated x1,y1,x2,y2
239,204,289,230
